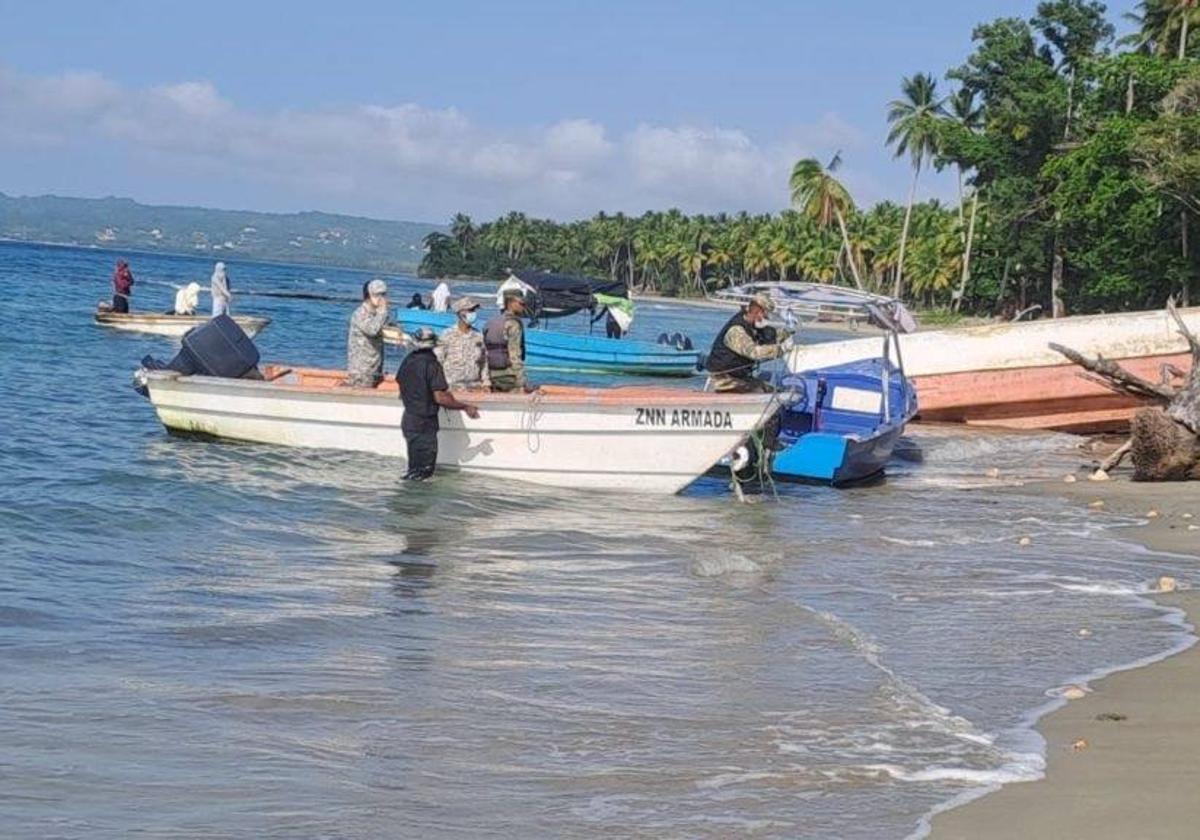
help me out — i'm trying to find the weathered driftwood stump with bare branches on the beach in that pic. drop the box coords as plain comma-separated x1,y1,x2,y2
1050,300,1200,481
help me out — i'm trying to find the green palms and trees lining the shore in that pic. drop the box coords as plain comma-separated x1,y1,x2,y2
421,0,1200,314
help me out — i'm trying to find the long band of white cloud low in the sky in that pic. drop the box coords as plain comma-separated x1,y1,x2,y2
0,66,878,220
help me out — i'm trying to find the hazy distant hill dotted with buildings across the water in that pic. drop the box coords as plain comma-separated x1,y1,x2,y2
0,193,445,272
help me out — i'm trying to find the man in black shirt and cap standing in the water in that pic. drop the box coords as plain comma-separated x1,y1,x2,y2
396,326,479,481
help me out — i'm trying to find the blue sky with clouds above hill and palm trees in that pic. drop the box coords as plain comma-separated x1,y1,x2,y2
0,0,1133,222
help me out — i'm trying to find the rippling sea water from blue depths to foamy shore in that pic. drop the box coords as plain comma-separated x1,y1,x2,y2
0,245,1198,839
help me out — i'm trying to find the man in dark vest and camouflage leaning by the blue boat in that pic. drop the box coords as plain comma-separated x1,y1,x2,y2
707,294,793,394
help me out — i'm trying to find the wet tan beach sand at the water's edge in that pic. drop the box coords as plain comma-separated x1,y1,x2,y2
931,473,1200,840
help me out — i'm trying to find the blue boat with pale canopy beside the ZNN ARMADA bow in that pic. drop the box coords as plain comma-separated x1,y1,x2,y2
710,283,917,486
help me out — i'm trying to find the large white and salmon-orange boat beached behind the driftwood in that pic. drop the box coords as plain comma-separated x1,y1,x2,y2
787,308,1200,432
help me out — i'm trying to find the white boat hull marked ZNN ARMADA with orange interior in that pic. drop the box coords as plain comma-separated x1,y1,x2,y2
140,366,775,493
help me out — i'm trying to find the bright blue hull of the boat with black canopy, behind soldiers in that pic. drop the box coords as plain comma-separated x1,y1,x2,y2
396,304,700,377
